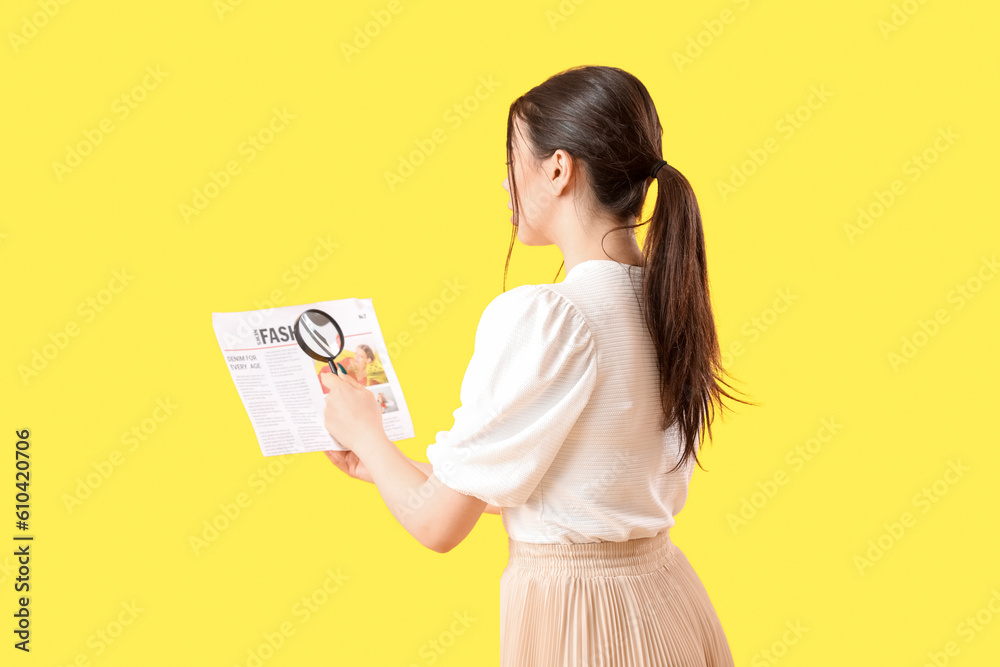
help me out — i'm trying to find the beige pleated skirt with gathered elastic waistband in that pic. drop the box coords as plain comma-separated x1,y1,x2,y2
500,530,733,667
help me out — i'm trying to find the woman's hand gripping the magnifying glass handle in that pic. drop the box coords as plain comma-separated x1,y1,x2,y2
320,373,385,456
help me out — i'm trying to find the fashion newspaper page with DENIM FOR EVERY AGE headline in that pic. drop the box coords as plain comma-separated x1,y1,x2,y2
212,299,415,456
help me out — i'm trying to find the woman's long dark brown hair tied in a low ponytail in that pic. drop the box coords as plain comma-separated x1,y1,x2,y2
504,66,757,472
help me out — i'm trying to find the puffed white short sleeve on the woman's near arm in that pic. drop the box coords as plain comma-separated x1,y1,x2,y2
427,285,597,507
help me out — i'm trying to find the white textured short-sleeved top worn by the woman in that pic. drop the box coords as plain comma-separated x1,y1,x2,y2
427,259,694,543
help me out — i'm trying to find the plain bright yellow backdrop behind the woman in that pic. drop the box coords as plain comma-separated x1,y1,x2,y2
0,0,1000,667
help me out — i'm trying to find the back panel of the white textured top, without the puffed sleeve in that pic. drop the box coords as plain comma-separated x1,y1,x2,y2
501,260,694,543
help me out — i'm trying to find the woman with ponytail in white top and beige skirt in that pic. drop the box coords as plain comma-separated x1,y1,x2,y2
325,67,747,667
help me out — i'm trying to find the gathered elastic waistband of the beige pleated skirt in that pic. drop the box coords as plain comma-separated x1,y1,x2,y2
507,529,677,576
